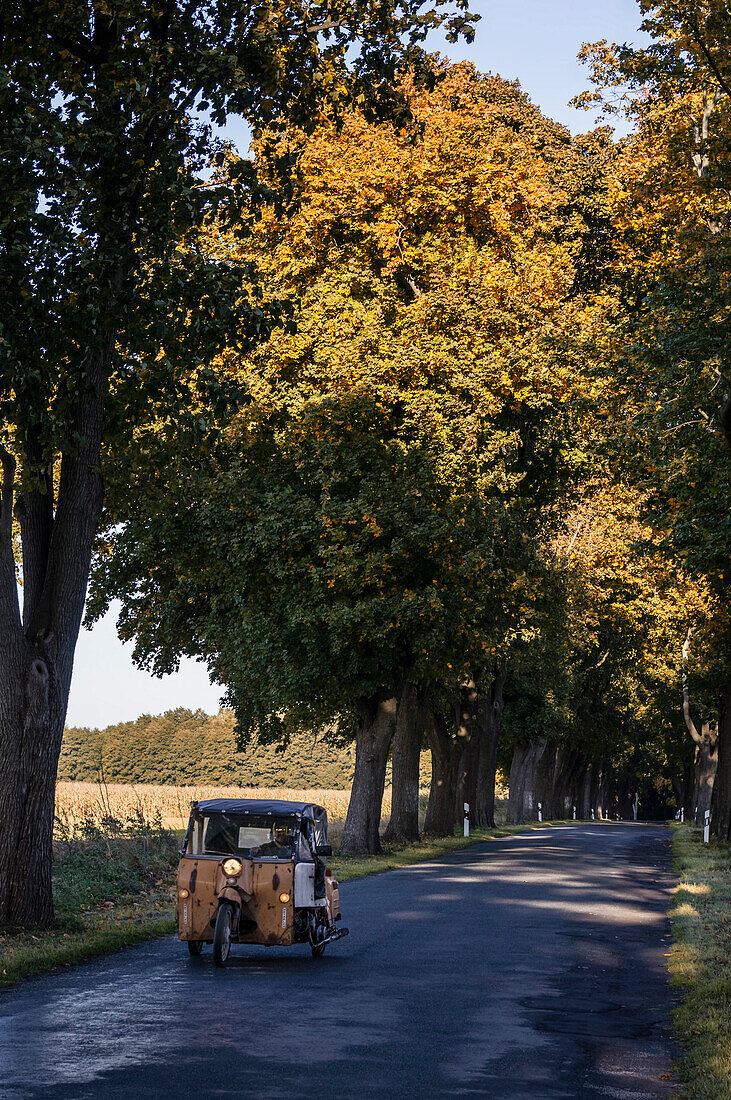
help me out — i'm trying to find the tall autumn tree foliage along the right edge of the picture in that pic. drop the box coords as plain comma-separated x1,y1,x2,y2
571,0,731,838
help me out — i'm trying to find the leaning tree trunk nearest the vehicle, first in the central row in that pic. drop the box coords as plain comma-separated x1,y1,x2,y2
340,693,398,856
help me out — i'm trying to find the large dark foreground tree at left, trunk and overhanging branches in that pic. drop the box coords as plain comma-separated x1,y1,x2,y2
0,0,473,925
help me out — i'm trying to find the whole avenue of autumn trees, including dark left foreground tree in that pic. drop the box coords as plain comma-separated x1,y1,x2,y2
0,0,731,923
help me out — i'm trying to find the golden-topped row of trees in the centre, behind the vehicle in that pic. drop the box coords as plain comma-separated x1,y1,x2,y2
92,51,726,851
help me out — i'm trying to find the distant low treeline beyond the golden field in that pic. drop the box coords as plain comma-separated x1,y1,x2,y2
58,707,413,789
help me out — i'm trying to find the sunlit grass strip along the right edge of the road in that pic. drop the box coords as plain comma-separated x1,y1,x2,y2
668,824,731,1100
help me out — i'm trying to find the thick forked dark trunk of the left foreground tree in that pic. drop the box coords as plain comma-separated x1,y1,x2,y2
0,354,107,926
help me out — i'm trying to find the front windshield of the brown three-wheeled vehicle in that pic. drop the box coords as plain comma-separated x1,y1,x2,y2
188,812,297,859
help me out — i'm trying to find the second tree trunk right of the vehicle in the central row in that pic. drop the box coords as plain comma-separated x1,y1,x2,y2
384,684,424,842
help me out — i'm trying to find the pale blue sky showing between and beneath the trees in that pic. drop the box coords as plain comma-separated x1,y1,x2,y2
68,0,640,726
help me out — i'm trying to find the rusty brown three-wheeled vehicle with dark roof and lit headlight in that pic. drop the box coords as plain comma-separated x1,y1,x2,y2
176,799,347,966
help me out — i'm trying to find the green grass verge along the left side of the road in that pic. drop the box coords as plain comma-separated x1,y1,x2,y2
0,822,552,987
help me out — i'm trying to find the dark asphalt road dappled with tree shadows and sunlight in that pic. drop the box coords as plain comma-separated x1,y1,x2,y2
0,824,674,1100
